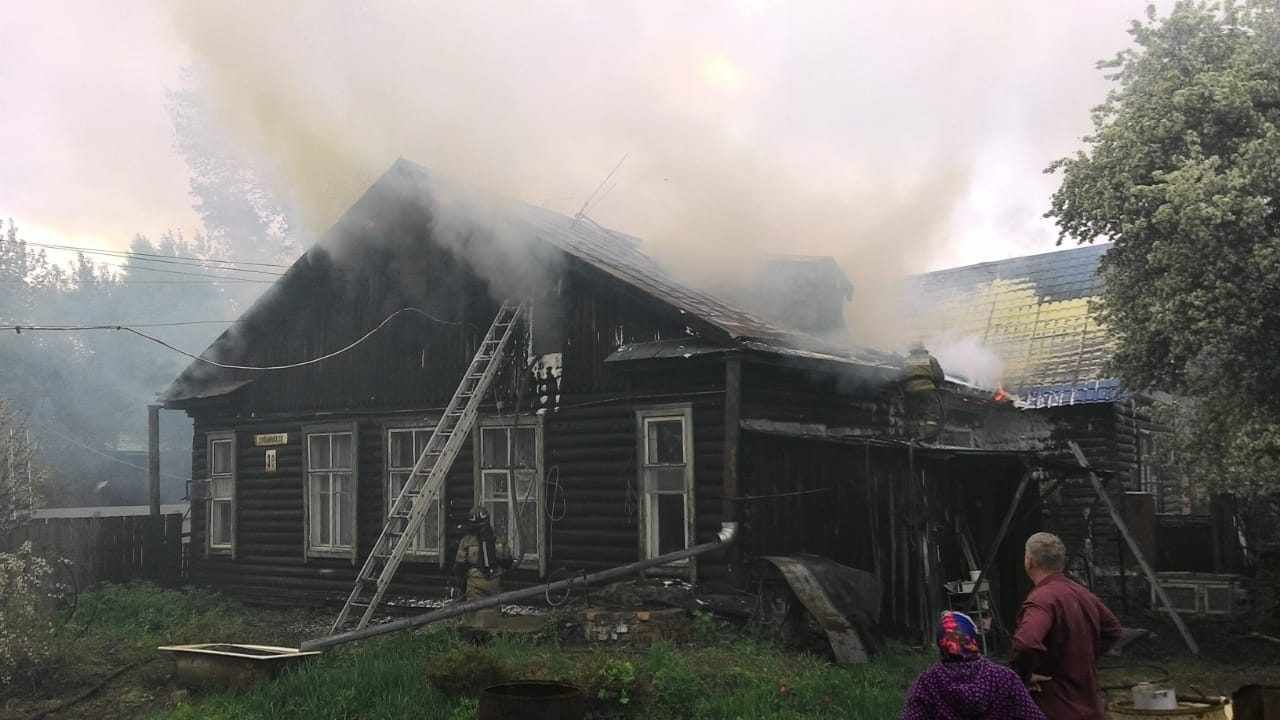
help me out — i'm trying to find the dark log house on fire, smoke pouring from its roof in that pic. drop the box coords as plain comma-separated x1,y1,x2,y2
161,160,1037,640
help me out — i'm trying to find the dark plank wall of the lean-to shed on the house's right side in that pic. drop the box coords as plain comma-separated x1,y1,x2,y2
741,432,1037,630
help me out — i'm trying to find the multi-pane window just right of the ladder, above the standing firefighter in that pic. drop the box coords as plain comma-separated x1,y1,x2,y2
476,419,544,568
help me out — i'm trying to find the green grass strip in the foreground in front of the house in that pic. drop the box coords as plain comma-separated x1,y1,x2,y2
154,630,929,720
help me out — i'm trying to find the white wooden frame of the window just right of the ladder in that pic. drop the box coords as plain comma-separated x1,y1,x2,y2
472,415,547,575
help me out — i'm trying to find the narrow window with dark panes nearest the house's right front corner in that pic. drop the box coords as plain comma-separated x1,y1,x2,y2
636,406,694,557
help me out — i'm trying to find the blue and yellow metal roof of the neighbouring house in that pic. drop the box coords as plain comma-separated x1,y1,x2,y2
910,245,1124,406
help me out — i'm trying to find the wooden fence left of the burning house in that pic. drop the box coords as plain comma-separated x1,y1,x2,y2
0,514,187,588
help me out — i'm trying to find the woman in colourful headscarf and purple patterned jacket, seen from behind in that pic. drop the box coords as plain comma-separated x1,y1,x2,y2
901,612,1046,720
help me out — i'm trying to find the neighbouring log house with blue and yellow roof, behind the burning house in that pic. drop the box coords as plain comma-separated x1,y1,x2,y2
913,245,1190,584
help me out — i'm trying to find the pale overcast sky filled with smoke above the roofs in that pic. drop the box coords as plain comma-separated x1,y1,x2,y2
0,0,1167,281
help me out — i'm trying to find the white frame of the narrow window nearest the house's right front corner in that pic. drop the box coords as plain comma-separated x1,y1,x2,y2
636,404,696,577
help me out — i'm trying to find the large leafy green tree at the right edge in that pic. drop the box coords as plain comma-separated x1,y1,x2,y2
1046,0,1280,489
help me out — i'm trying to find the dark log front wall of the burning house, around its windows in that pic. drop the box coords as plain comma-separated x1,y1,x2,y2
192,353,726,602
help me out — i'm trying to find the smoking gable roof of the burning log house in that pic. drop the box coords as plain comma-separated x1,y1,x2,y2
160,159,901,402
